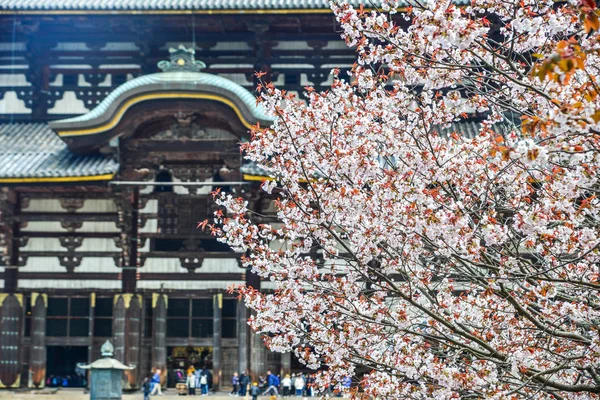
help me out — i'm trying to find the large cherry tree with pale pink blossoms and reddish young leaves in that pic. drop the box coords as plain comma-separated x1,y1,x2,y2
212,0,600,399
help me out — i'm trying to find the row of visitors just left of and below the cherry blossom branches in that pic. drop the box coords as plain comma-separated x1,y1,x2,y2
230,371,316,399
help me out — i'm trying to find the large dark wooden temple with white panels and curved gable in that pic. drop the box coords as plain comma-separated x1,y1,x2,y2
0,0,358,389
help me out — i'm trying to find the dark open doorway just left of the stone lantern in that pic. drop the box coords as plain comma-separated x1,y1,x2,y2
46,346,88,387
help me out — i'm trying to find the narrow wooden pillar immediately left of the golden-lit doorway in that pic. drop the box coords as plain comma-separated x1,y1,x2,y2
152,293,169,387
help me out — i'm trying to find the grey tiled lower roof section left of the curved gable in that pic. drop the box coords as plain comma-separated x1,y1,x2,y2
0,123,119,183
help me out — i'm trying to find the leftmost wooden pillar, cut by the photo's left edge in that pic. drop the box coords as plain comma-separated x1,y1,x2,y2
0,293,23,388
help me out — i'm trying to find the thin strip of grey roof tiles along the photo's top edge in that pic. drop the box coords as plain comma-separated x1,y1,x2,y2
0,0,470,10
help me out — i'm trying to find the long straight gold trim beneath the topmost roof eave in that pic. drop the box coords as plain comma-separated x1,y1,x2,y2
0,8,356,15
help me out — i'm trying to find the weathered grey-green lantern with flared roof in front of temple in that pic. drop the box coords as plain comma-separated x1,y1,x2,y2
81,340,135,400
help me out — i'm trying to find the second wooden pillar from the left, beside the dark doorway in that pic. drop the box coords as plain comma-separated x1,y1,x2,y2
29,293,48,388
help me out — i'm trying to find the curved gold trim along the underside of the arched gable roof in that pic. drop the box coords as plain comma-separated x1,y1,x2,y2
57,93,252,137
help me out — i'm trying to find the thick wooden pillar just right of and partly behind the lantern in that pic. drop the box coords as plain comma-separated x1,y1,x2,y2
113,293,142,390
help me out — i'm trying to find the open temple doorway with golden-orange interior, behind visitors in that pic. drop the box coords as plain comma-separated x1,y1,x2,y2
167,346,213,387
